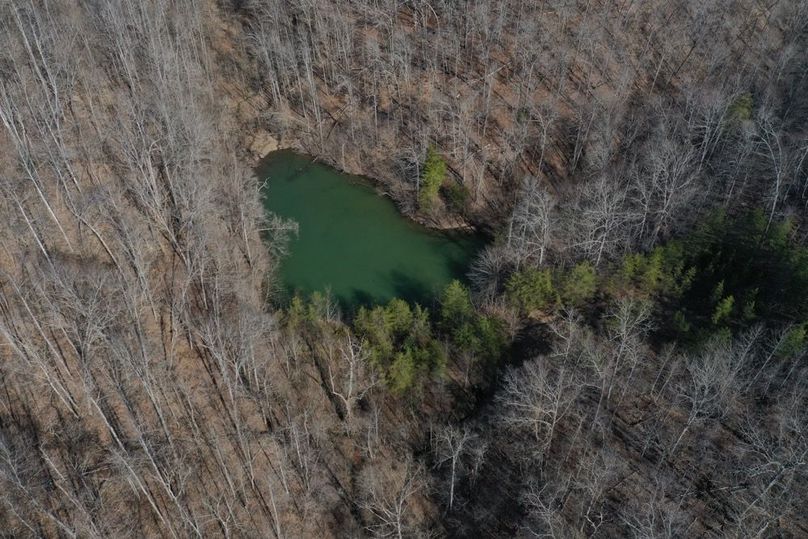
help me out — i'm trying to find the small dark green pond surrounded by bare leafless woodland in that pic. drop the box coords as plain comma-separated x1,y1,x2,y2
259,150,482,309
